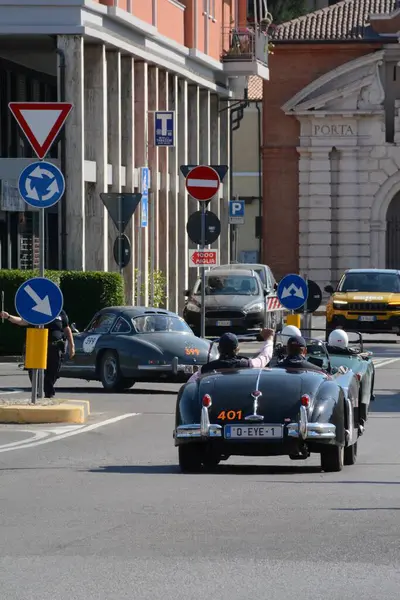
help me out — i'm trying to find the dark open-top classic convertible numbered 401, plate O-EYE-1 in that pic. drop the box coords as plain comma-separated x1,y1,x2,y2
173,340,362,472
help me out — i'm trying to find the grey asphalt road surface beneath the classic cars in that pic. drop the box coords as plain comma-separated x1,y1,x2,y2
0,344,400,600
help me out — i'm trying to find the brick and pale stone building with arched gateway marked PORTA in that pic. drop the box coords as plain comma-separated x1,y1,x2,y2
263,0,400,287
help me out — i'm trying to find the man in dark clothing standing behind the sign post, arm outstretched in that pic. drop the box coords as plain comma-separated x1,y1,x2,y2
0,310,75,398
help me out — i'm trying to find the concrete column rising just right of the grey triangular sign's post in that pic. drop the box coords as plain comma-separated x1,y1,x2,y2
121,56,136,305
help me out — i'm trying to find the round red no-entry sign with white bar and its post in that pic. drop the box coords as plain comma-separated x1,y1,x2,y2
186,165,221,338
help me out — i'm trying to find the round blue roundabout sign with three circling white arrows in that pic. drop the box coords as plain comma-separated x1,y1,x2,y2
18,161,65,208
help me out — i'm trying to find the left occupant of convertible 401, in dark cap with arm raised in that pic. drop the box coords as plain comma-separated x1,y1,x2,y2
188,328,274,383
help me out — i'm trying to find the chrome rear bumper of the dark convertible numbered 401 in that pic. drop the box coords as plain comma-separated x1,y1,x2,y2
174,406,336,440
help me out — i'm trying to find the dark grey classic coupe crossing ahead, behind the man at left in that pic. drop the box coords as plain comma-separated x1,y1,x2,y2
60,306,218,391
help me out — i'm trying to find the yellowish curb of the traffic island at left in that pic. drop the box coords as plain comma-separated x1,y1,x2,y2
0,400,90,425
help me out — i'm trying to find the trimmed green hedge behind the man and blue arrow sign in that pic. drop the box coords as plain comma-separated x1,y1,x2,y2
0,269,125,356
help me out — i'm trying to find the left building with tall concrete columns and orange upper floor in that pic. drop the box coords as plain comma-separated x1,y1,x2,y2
0,0,269,311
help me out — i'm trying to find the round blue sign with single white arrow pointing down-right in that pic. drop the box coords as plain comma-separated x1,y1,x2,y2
15,277,64,325
